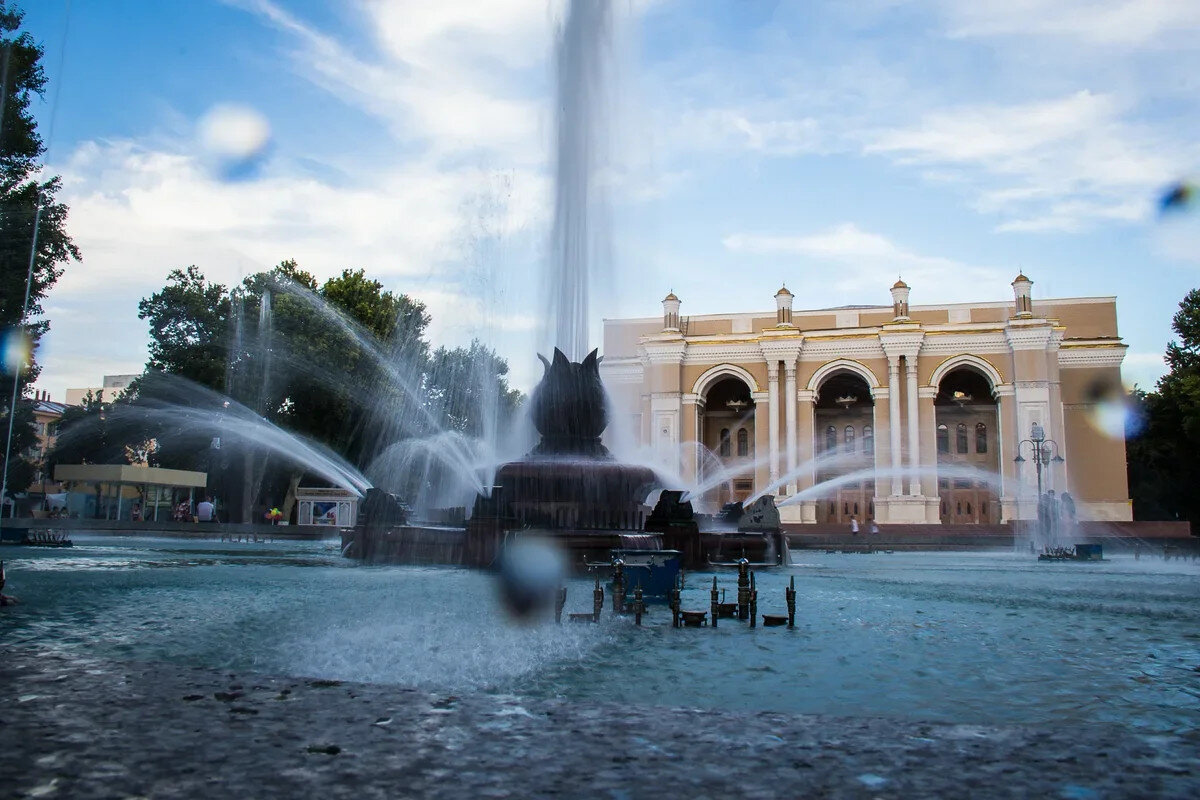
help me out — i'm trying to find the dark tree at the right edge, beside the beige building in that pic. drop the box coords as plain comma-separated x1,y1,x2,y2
1126,289,1200,525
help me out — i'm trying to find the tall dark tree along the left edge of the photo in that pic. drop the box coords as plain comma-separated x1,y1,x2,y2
0,0,79,492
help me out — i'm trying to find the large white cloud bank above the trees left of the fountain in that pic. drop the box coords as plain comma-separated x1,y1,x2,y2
38,142,546,395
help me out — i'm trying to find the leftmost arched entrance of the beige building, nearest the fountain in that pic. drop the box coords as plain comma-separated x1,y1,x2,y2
700,377,755,509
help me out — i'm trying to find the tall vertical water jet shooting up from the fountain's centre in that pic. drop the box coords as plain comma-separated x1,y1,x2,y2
542,0,612,361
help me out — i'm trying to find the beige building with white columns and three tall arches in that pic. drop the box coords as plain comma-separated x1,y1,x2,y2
601,275,1132,524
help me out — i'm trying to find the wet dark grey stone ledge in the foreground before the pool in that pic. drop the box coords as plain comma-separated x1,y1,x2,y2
0,646,1200,799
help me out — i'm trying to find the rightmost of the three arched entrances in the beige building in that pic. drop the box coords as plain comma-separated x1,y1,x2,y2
934,366,1000,524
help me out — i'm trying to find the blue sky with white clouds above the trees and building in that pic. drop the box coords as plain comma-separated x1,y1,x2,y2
17,0,1200,398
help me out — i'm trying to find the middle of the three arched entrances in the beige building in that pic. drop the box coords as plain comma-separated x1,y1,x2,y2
812,369,875,524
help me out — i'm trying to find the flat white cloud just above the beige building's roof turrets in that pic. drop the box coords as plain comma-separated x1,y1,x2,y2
722,222,1008,299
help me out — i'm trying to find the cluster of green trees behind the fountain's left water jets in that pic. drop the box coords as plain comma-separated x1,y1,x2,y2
134,260,521,520
